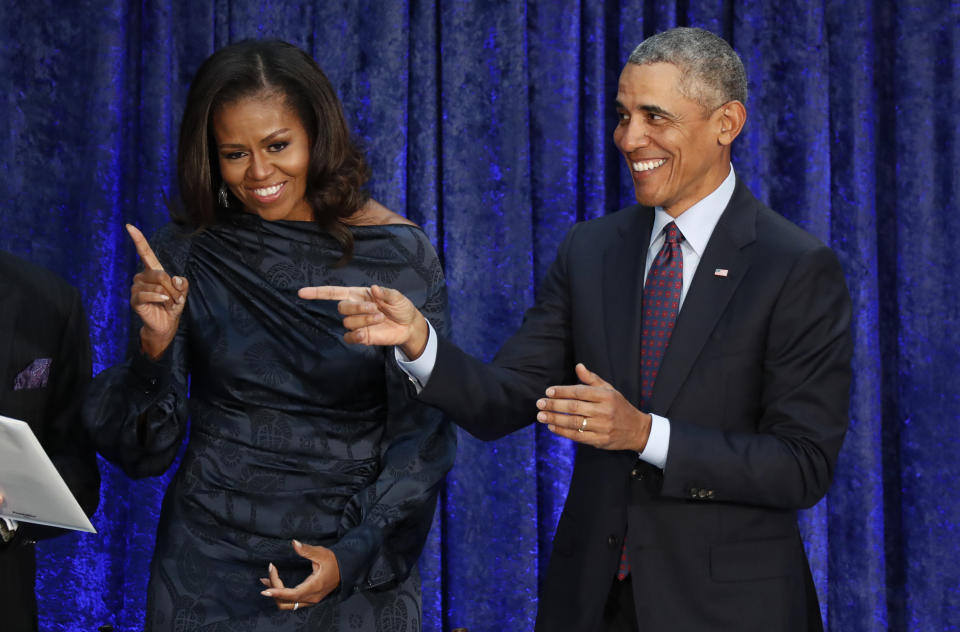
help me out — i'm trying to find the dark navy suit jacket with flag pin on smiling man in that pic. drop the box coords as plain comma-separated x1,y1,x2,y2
420,181,852,632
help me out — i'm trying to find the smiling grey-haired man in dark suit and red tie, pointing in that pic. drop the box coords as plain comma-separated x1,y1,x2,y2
301,28,852,632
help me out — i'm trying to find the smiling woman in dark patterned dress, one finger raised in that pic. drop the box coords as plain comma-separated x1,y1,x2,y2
85,41,455,632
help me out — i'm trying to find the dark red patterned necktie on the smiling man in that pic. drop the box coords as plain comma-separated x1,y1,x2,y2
617,222,683,581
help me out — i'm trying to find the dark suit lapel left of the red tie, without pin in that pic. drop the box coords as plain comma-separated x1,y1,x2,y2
600,207,653,402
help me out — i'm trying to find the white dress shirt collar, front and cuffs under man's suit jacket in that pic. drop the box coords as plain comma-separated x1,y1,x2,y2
394,165,737,468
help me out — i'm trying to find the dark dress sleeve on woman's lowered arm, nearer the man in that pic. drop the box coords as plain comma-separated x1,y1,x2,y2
331,231,456,599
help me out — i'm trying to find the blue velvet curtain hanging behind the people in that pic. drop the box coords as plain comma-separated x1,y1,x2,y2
0,0,960,632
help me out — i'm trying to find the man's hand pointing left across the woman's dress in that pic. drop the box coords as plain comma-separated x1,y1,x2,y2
298,285,430,360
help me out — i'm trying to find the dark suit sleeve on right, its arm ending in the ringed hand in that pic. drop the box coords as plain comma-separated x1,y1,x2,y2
662,247,852,509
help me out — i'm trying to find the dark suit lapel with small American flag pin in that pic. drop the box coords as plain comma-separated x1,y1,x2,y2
652,180,759,415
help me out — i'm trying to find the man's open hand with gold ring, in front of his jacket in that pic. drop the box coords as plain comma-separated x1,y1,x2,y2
537,364,650,452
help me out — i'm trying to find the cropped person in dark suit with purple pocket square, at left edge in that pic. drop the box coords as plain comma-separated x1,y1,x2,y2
0,252,100,632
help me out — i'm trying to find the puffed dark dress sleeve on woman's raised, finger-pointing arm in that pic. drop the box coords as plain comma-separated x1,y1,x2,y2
83,226,190,478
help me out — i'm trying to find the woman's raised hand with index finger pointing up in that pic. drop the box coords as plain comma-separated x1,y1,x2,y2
127,224,190,359
